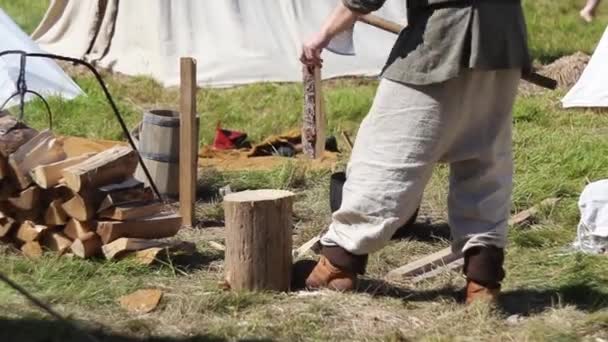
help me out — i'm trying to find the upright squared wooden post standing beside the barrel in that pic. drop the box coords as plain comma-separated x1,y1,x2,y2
179,58,198,227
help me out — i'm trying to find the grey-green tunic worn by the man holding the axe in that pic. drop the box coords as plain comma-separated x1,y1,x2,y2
342,0,531,85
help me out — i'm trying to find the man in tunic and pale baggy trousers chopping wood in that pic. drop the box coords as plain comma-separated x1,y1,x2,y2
301,0,531,303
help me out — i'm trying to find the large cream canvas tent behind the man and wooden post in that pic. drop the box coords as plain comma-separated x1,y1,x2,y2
33,0,406,86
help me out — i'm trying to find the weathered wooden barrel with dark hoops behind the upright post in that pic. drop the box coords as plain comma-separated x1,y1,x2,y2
136,109,198,197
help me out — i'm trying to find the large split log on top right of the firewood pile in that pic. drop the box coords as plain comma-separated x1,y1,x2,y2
61,146,138,192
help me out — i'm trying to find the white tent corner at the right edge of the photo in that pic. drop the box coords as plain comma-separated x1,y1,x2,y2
562,28,608,108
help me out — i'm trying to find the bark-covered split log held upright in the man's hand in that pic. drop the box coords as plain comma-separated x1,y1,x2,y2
302,66,326,159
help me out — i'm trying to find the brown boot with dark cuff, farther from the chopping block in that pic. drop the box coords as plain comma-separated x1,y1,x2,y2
464,247,505,304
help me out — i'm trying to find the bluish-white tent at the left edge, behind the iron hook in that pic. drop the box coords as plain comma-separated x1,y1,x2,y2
0,9,82,106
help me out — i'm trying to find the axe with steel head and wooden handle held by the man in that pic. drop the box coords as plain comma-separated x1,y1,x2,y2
327,14,557,90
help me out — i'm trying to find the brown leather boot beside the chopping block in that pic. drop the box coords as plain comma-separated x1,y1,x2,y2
306,256,357,292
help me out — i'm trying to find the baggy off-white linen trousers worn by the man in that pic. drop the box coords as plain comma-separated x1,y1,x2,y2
321,69,521,255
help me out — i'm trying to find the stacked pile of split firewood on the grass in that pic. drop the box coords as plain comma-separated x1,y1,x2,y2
0,116,183,263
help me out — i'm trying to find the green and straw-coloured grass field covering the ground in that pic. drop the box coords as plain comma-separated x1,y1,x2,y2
0,0,608,342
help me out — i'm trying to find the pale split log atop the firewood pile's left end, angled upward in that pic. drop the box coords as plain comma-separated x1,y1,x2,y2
8,131,66,189
